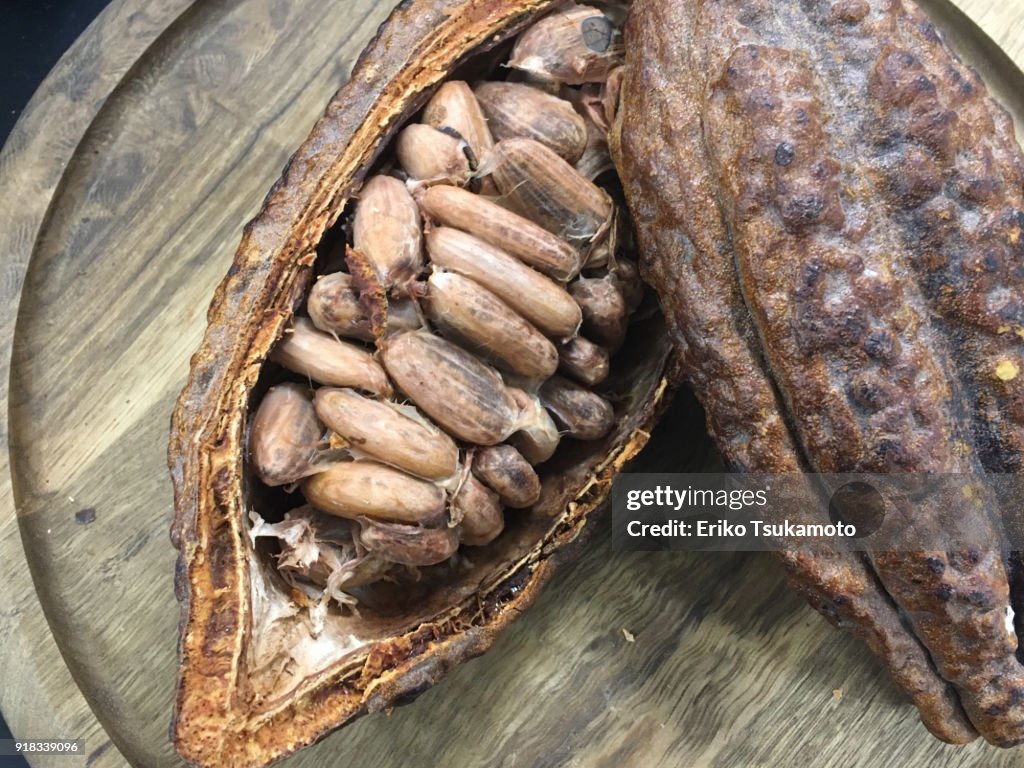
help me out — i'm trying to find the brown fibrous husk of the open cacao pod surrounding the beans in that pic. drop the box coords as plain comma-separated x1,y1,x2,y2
169,0,677,766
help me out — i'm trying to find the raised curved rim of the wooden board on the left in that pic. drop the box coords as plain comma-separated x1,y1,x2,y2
0,0,195,768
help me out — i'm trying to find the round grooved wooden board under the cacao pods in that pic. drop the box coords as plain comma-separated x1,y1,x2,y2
0,0,1024,768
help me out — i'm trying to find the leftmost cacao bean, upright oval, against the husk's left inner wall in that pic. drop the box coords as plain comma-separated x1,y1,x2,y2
249,383,324,485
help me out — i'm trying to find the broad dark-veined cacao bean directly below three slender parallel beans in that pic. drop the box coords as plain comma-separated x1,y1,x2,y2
381,331,518,445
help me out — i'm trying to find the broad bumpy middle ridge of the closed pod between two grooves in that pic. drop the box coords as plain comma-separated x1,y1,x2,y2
706,13,1024,743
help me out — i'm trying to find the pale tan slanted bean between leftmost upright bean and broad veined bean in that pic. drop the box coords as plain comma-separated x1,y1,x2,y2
314,387,459,480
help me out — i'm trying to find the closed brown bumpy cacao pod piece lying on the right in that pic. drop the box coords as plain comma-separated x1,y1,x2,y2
612,0,1024,746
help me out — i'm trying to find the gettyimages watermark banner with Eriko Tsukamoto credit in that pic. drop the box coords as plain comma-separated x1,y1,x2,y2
612,473,1024,552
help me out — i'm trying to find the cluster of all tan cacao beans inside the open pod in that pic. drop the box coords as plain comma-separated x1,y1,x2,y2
248,5,644,604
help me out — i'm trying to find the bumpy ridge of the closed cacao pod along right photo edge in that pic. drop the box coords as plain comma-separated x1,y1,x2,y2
862,4,1024,704
